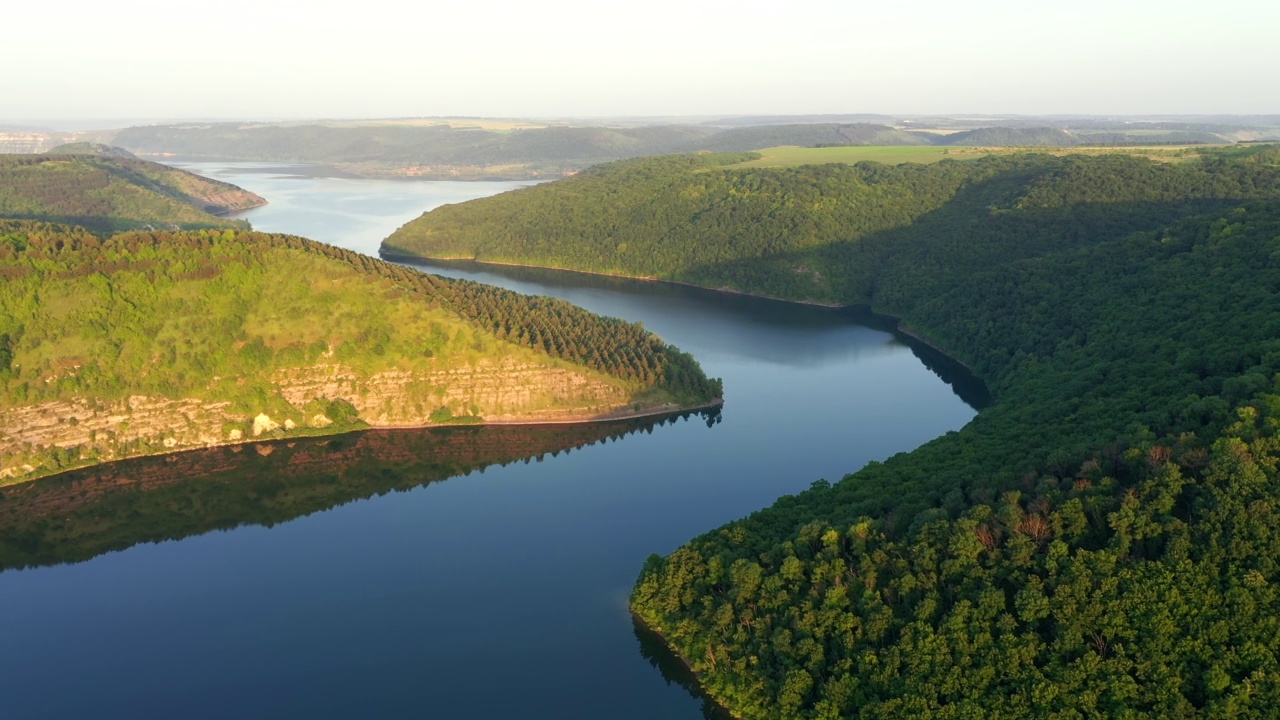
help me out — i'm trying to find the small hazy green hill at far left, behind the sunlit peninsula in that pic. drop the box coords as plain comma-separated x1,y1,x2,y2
0,152,266,233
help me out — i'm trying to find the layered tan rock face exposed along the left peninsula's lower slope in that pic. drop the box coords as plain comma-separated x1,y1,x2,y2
0,361,628,484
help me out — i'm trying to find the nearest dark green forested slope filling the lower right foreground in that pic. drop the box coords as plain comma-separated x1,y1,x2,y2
632,204,1280,719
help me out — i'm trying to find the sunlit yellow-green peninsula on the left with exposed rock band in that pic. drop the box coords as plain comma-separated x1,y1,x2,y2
0,222,721,484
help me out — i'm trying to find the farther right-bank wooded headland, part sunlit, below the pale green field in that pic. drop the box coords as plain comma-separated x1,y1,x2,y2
383,149,1280,304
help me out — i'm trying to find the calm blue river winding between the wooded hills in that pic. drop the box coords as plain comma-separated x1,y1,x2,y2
0,163,974,720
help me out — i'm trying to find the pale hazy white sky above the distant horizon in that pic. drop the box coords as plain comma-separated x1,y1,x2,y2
0,0,1280,119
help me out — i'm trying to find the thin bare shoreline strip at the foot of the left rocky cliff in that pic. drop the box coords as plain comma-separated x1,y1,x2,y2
0,397,724,492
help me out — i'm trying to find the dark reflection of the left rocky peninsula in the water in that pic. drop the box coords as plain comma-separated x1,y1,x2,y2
0,407,721,570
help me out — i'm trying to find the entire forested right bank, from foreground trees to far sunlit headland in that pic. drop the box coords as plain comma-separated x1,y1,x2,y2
385,147,1280,719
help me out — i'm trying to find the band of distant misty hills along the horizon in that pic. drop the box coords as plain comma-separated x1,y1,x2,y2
0,114,1280,179
